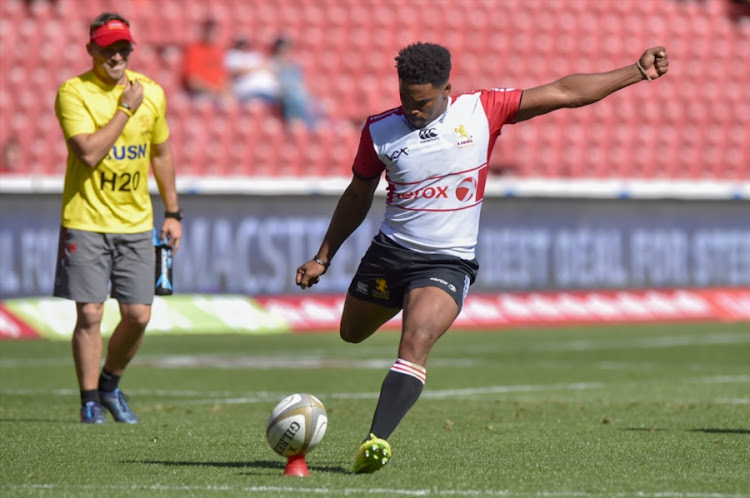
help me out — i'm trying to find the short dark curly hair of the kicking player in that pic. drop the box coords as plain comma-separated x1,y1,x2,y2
396,42,451,86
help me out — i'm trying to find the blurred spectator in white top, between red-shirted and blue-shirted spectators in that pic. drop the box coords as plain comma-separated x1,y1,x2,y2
224,37,281,109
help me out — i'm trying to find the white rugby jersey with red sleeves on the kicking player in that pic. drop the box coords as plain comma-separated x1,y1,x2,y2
352,89,523,260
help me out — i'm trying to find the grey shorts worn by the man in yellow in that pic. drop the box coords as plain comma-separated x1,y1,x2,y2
54,227,154,304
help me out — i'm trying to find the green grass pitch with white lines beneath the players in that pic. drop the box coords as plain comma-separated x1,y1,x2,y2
0,324,750,498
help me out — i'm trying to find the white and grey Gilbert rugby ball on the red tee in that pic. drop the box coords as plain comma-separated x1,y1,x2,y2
266,393,328,457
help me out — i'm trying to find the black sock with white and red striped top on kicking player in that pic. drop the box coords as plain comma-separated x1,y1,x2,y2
370,358,427,439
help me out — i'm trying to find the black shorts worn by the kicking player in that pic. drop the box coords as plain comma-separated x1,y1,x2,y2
349,232,479,312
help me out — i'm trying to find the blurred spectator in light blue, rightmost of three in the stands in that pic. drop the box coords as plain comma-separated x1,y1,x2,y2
271,36,317,128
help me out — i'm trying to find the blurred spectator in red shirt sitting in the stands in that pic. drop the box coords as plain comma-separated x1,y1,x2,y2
182,18,231,100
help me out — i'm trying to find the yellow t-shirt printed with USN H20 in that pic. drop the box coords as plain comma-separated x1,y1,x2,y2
55,71,169,233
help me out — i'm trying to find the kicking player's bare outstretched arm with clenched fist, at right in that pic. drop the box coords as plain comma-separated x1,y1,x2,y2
516,47,669,123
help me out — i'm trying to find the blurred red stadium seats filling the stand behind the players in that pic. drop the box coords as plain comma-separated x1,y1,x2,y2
0,0,750,181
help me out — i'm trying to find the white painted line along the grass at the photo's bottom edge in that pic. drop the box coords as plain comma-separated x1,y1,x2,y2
0,484,750,498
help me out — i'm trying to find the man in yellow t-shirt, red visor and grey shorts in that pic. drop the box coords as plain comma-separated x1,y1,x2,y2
54,12,182,424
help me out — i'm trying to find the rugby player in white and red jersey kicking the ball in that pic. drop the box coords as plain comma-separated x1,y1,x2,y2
296,43,669,473
